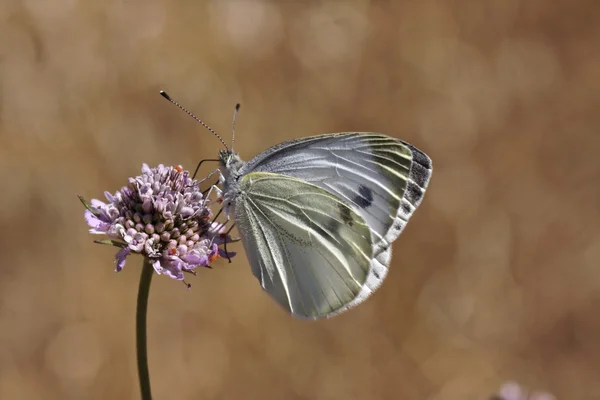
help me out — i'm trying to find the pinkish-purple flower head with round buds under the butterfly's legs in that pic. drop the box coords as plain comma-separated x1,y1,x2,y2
80,164,235,280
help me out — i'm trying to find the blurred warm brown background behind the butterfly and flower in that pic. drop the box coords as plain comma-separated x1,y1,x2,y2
0,0,600,400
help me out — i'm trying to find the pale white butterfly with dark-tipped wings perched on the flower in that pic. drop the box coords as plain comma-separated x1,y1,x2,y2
161,92,432,319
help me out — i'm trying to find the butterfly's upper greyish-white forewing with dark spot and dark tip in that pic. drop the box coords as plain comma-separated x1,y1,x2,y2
242,132,432,308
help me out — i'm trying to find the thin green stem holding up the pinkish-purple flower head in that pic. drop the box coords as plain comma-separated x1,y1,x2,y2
136,258,154,400
